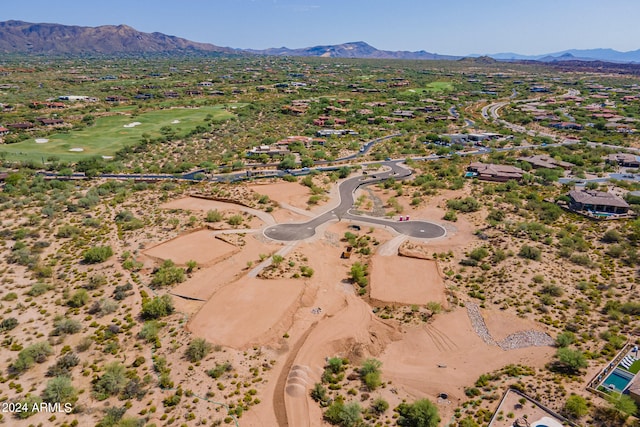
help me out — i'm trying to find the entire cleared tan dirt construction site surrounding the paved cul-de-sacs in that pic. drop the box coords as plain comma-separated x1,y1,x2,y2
134,179,553,426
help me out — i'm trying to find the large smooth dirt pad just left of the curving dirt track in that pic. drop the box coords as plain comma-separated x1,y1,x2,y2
187,277,305,349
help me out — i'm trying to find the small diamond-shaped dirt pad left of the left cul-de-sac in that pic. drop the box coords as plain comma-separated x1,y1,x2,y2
144,230,238,267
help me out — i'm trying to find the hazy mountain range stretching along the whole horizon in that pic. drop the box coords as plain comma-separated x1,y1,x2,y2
0,20,640,63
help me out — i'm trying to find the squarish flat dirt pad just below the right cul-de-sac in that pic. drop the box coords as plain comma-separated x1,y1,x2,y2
371,256,447,308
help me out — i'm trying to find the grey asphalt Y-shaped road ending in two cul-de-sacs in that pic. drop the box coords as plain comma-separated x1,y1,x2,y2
264,160,446,242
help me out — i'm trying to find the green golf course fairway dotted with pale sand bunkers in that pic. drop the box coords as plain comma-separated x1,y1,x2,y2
0,104,239,162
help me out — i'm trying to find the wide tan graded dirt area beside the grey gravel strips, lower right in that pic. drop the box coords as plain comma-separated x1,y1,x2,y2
379,307,555,419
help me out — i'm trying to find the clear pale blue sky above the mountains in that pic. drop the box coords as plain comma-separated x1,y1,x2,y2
5,0,640,55
